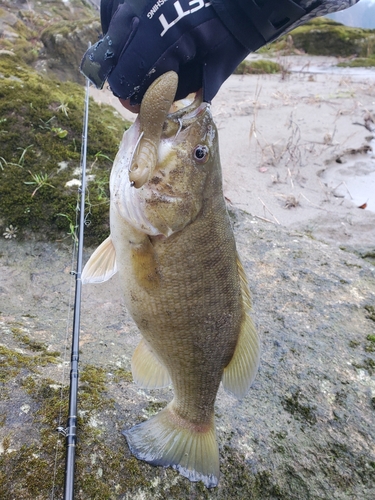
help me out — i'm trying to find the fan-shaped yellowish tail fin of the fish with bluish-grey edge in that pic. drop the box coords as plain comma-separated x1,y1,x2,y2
123,401,220,488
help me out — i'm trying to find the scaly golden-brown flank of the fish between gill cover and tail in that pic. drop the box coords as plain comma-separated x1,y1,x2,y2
111,184,242,422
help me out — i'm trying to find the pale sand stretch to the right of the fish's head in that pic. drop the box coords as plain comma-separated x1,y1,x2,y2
91,55,375,249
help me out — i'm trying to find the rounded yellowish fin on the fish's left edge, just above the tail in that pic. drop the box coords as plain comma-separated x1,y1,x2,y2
131,340,171,389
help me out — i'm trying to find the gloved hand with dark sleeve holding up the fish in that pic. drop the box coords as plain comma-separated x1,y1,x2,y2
81,0,358,111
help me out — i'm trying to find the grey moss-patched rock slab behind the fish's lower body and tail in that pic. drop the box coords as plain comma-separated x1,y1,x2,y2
0,207,375,500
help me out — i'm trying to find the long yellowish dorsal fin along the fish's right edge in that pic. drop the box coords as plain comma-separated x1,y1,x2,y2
222,258,260,398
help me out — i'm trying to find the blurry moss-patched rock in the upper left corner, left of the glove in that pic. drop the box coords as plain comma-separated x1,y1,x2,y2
0,0,101,78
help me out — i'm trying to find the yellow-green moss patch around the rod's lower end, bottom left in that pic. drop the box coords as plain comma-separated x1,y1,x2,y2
0,354,153,500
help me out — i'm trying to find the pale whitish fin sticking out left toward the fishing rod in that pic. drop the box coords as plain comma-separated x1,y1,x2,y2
81,236,117,284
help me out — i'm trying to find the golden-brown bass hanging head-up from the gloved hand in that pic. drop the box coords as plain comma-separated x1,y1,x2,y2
81,75,260,488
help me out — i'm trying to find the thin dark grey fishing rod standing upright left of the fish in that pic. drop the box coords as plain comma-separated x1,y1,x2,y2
57,74,90,500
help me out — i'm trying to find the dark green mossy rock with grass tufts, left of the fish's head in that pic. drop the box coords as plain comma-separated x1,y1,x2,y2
0,54,129,244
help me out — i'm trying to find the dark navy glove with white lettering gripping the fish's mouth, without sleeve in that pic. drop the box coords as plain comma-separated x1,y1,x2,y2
81,0,249,104
